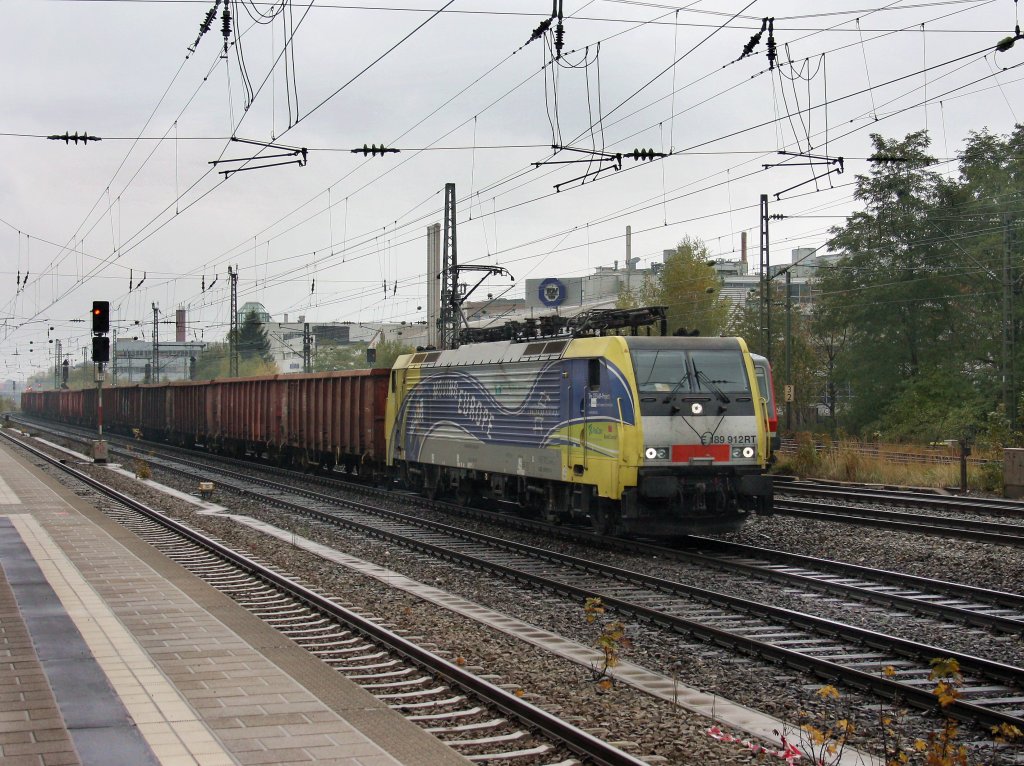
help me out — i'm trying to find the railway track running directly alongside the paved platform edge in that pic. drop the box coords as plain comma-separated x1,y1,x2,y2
0,431,645,766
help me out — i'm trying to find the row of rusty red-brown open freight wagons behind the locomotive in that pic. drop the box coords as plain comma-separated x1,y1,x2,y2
22,370,389,476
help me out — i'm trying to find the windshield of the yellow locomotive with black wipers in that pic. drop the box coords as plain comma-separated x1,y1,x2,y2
632,348,751,396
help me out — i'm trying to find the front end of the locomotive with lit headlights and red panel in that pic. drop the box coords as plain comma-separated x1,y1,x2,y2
609,337,772,537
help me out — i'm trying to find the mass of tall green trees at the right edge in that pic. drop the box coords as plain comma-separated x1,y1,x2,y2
806,126,1024,444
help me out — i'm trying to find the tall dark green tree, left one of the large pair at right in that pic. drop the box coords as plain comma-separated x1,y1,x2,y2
818,131,974,438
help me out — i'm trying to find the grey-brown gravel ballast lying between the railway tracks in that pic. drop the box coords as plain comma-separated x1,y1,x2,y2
16,434,1024,764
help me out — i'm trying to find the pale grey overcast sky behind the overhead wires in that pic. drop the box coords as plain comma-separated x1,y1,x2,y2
0,0,1024,379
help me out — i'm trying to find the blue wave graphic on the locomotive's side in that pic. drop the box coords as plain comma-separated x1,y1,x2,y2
393,359,636,461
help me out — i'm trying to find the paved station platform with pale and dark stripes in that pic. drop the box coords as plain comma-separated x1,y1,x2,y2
0,436,468,766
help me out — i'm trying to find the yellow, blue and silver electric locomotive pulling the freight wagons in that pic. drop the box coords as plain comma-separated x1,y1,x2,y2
385,323,772,538
